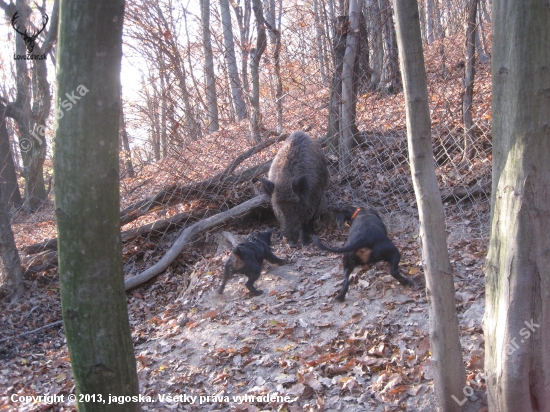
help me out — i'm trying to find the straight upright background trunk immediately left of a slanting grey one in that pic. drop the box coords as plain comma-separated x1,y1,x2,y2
201,0,220,133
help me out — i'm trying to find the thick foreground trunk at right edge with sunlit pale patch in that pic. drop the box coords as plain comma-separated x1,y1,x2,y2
483,0,550,412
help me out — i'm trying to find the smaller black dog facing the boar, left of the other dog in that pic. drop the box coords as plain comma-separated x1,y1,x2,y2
216,229,286,296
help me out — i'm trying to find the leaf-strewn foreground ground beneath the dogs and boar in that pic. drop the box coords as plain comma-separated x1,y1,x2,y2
0,209,487,412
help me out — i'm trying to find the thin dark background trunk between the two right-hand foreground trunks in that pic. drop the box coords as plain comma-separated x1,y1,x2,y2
461,0,479,166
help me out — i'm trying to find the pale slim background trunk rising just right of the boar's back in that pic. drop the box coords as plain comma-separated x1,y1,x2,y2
338,0,363,175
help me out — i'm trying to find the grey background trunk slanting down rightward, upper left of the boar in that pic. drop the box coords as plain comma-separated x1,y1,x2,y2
219,0,248,120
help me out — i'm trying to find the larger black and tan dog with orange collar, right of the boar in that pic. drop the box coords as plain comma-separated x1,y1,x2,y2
313,206,414,302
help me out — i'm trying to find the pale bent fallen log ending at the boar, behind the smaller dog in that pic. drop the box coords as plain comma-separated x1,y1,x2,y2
124,195,270,290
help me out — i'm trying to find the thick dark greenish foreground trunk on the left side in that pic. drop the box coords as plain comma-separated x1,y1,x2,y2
54,0,140,411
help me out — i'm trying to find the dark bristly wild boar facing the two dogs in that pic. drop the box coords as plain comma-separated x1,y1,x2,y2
262,132,328,247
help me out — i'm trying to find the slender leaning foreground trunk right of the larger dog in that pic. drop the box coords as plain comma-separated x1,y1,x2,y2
395,0,466,412
